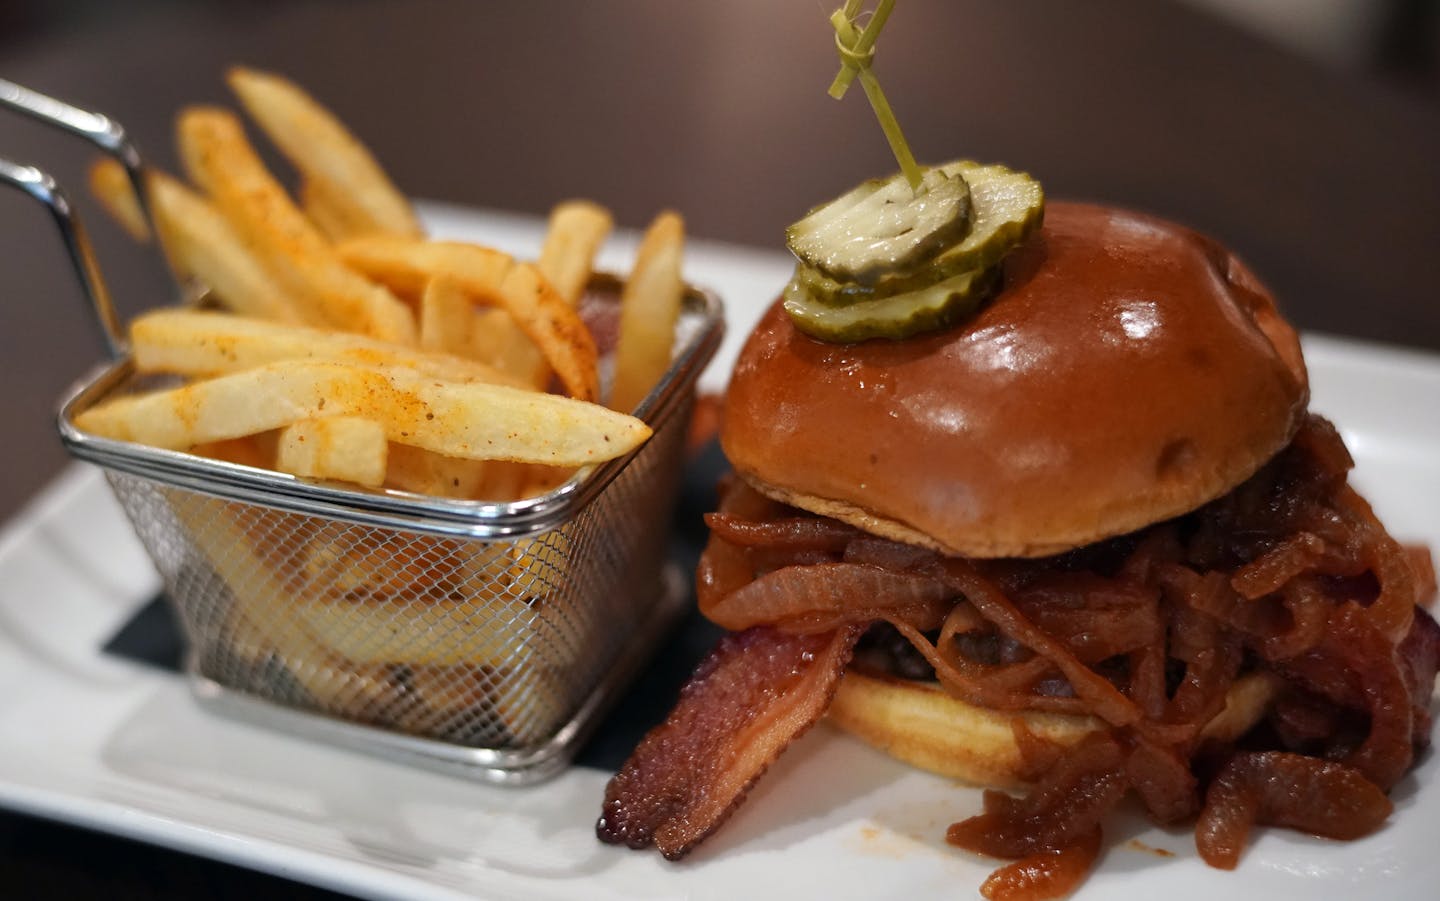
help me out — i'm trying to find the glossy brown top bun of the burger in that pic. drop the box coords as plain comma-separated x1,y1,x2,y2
720,203,1309,557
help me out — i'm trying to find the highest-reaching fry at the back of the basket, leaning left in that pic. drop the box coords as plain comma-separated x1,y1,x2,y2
226,68,425,237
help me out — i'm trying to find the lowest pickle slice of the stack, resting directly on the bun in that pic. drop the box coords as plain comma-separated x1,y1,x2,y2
785,266,1001,343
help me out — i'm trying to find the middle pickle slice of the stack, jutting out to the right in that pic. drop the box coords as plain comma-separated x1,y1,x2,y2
796,160,1045,305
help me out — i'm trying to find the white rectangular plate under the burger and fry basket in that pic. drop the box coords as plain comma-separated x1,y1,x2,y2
0,204,1440,901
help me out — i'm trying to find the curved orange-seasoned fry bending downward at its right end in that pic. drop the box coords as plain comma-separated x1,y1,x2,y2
338,237,599,400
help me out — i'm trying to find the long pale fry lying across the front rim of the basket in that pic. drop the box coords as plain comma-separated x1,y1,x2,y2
75,360,649,466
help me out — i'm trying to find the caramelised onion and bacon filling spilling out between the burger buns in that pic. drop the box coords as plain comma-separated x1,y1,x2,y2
599,416,1440,897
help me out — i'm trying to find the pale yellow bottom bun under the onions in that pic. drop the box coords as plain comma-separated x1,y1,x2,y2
829,666,1274,787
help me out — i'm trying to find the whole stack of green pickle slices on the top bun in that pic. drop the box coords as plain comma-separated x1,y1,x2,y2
785,160,1044,341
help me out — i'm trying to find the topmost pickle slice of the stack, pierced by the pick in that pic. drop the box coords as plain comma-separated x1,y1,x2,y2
785,168,971,284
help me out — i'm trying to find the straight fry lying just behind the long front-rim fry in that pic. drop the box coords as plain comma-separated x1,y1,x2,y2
130,309,526,387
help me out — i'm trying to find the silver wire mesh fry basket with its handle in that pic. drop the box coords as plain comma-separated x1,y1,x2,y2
0,82,723,784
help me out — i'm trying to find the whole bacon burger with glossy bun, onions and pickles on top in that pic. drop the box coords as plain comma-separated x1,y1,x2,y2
598,164,1440,898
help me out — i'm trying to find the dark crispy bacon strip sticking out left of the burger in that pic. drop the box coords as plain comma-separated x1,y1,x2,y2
595,626,864,861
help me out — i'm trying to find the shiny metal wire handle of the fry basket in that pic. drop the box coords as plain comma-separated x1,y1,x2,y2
0,78,154,360
